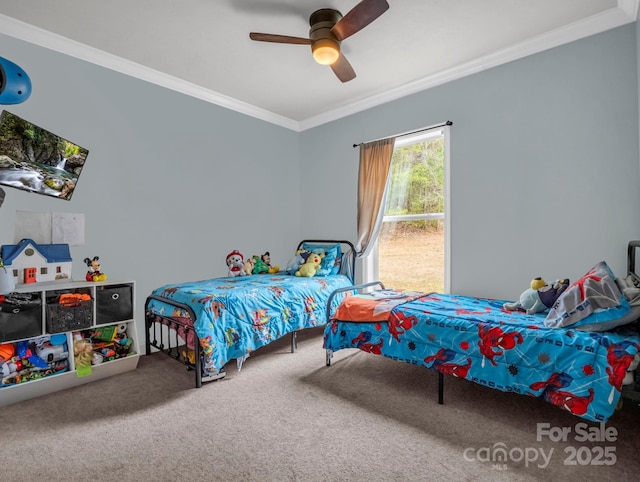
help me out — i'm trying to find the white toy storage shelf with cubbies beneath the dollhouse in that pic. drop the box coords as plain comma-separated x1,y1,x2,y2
0,280,140,407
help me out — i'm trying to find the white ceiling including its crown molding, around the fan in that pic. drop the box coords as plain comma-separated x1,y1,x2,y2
0,0,640,131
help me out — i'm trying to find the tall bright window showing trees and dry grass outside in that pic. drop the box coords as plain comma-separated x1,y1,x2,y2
365,127,449,292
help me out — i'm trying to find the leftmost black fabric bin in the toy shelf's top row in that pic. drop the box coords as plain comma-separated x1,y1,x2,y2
0,294,42,342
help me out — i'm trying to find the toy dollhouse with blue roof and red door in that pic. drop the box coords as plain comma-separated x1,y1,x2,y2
0,239,72,284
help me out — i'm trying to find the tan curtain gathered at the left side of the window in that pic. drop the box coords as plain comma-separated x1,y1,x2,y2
356,137,396,257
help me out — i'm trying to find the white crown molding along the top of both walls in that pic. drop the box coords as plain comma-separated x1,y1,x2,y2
0,0,640,132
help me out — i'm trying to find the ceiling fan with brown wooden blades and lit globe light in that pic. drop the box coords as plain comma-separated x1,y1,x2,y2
249,0,389,82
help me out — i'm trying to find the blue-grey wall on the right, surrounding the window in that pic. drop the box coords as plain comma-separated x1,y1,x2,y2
302,25,640,298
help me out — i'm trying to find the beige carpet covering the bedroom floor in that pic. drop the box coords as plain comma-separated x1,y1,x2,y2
0,329,640,482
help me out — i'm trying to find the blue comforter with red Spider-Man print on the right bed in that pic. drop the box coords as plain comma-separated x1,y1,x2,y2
324,294,640,422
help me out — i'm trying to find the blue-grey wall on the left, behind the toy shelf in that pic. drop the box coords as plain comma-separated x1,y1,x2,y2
0,35,301,336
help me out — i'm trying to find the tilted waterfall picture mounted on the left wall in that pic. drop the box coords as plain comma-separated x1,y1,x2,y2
0,110,89,201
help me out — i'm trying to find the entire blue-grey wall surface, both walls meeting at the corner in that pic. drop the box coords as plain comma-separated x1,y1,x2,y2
0,25,640,336
